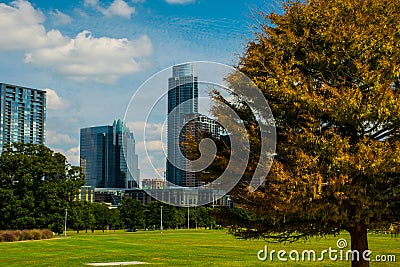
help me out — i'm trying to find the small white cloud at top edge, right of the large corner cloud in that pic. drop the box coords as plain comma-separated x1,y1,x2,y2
84,0,136,19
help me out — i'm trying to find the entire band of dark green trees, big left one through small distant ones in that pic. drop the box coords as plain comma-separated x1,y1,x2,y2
0,143,219,233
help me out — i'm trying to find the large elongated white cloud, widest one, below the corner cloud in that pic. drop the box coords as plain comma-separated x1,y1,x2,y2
25,31,152,83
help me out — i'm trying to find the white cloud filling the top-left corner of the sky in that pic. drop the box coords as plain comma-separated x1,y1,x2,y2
0,0,66,50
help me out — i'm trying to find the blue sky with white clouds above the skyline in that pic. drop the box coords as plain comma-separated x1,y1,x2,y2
0,0,274,178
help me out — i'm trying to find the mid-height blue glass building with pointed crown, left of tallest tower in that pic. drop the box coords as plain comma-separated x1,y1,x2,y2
80,120,140,189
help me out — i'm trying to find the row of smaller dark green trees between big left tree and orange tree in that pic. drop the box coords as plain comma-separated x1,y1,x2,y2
67,197,216,233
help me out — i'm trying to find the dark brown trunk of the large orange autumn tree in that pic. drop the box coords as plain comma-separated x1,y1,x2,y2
344,223,369,267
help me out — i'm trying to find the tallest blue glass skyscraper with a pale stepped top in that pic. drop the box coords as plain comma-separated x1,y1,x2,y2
166,64,199,186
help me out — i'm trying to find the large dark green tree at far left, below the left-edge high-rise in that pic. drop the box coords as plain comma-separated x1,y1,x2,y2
0,143,84,233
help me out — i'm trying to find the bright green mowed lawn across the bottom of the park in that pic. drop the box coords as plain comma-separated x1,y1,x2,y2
0,229,400,266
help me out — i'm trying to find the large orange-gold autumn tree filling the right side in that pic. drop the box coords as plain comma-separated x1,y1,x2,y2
206,0,400,266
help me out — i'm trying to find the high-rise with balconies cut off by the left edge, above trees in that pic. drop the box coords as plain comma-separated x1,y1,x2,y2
0,83,46,153
